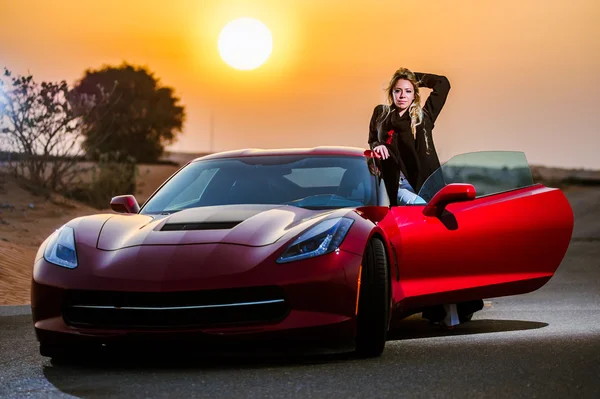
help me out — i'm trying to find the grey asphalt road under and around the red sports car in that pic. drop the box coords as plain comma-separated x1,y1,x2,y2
0,188,600,398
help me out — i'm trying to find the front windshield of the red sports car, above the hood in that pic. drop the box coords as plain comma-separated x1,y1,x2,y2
140,155,377,214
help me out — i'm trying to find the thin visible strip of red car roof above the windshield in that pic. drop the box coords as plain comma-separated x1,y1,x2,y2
191,146,365,162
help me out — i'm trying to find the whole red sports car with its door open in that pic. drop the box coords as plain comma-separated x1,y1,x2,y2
31,147,573,356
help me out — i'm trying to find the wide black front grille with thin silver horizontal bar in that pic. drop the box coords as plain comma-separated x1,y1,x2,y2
63,287,289,329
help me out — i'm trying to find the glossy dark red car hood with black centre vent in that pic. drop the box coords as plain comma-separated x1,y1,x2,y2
97,205,335,250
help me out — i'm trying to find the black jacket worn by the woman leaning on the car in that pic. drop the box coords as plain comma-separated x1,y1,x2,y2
369,72,450,205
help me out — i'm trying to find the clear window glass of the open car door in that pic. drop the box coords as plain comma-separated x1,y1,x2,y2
419,151,534,202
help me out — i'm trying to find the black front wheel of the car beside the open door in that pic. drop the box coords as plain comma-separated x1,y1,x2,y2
356,238,390,357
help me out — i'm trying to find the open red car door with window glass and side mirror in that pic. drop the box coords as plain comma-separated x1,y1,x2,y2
387,151,573,309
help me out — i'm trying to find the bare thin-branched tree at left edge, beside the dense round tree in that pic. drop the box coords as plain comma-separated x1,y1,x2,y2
0,68,110,191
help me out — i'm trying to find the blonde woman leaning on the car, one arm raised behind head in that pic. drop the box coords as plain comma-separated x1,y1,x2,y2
369,68,450,205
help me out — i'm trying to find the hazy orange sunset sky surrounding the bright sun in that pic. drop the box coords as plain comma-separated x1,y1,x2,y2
0,0,600,169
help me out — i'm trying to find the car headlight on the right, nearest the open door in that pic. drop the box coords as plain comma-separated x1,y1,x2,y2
277,217,354,263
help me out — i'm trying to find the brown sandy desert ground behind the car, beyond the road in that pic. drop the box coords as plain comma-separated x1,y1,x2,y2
0,154,600,305
